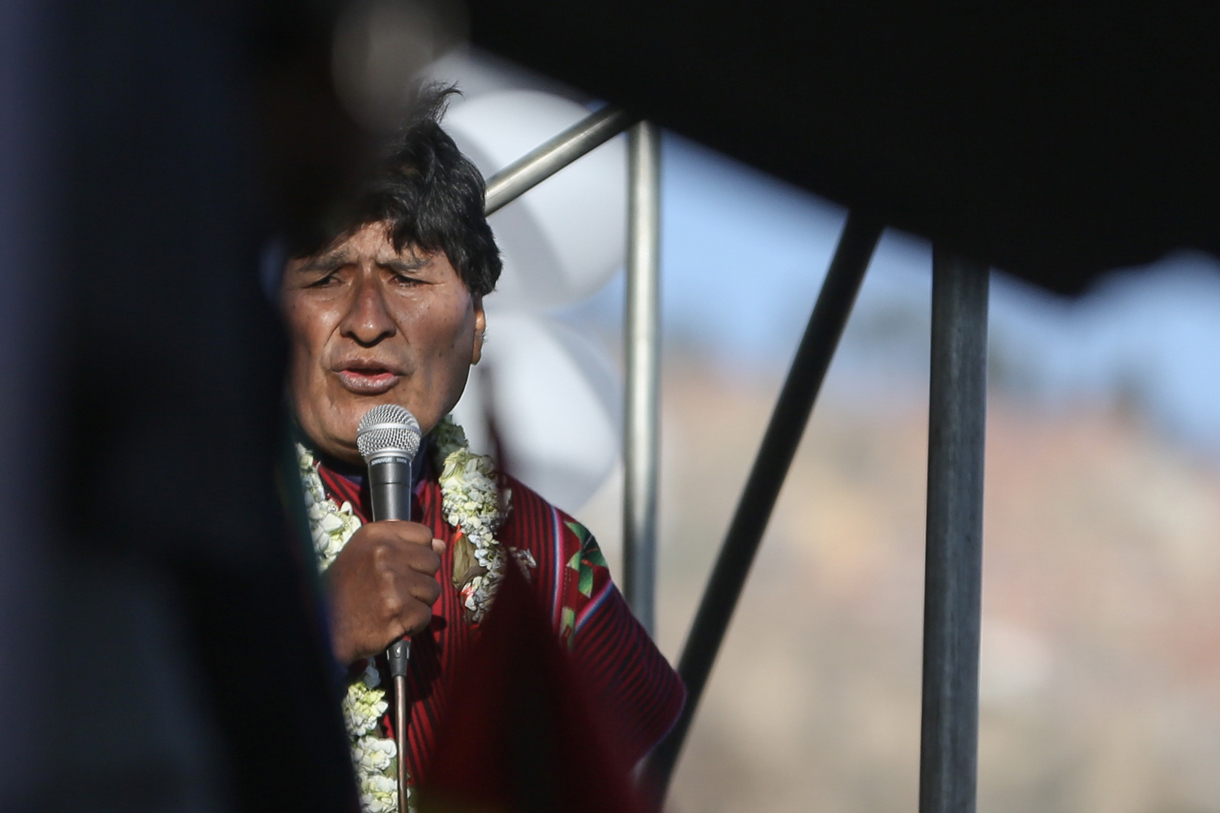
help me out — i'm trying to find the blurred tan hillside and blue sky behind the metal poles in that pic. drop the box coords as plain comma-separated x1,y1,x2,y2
437,47,1220,813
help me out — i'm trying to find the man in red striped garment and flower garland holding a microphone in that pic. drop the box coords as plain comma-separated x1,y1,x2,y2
281,90,684,809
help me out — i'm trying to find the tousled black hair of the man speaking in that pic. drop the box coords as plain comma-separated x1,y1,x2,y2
309,84,501,297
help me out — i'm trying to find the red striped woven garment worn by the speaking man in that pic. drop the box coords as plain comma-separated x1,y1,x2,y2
318,464,686,782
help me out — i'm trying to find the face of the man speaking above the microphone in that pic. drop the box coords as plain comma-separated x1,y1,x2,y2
282,223,484,464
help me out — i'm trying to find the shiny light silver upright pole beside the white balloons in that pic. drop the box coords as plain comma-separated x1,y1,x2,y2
622,121,661,635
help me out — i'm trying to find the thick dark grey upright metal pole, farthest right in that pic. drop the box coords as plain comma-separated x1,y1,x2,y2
919,249,988,813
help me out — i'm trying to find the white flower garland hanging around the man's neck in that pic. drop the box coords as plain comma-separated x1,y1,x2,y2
296,417,524,813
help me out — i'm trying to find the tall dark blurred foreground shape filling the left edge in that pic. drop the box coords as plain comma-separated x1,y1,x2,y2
0,0,409,813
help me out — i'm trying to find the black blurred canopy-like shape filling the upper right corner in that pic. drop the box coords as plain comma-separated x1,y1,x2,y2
468,0,1220,293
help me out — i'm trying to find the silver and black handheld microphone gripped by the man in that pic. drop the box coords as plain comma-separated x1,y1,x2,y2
356,404,422,813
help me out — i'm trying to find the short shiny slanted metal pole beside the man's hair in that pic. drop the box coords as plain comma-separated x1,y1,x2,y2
483,105,638,215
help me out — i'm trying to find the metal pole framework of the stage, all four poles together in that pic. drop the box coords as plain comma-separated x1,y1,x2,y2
486,106,989,813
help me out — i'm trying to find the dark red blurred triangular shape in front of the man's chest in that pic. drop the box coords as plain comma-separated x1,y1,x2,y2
420,563,643,813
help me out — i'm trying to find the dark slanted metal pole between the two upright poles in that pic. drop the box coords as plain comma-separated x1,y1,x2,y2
645,214,882,801
